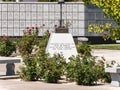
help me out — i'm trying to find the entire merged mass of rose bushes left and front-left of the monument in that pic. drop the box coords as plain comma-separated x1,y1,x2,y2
18,26,66,83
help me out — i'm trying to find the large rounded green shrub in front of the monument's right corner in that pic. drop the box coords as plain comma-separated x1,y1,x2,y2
67,56,99,85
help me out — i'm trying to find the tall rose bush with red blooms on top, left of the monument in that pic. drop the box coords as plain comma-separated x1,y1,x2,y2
18,27,54,81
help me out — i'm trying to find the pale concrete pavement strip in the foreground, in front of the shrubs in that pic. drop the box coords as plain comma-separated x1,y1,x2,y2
0,79,120,90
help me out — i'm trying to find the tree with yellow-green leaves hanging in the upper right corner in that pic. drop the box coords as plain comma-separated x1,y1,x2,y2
83,0,120,40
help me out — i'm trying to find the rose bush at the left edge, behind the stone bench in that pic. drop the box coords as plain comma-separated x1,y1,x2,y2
0,36,16,56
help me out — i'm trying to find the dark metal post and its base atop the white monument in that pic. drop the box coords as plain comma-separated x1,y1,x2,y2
55,0,68,33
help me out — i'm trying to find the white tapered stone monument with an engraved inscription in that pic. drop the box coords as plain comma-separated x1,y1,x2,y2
46,33,78,62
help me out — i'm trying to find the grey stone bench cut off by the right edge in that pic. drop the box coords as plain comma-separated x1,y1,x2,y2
105,67,120,87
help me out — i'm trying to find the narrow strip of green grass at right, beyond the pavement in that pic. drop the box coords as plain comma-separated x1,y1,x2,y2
90,44,120,50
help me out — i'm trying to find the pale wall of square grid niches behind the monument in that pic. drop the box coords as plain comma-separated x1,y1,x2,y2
0,0,114,43
